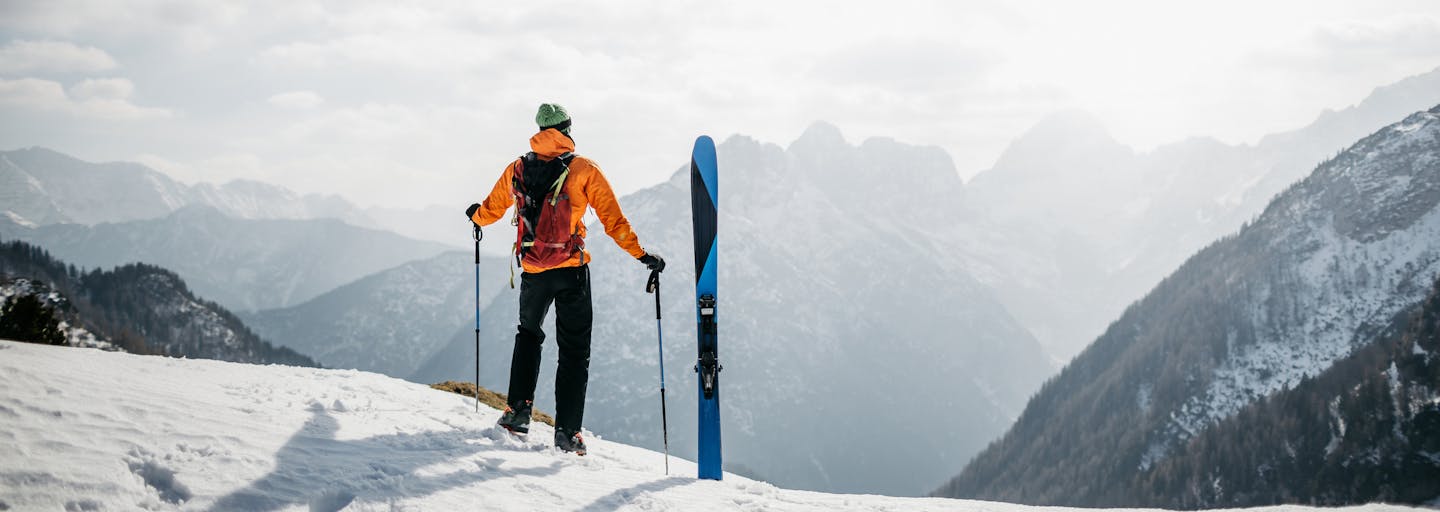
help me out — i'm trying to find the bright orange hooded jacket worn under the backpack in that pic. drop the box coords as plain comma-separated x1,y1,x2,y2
469,128,645,273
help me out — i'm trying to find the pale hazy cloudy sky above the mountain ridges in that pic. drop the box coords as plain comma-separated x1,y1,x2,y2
0,0,1440,209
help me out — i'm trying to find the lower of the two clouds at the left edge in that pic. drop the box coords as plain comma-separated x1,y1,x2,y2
0,78,174,121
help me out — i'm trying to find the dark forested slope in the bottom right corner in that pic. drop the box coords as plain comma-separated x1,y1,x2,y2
1140,274,1440,509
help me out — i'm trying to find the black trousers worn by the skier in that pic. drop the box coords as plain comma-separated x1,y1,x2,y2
508,265,593,431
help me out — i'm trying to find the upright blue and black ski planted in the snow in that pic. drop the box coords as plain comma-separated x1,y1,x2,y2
690,135,723,480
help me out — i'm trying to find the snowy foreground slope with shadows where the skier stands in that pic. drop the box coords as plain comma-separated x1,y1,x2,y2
0,341,1428,512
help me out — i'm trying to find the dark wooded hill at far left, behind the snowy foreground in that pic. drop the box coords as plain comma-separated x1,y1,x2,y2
0,242,315,367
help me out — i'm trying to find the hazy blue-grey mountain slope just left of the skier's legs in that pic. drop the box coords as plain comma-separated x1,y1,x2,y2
243,252,507,377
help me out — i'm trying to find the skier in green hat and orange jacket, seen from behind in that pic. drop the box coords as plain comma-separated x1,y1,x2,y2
465,104,665,456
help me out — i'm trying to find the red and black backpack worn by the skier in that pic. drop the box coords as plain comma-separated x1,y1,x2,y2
510,152,585,268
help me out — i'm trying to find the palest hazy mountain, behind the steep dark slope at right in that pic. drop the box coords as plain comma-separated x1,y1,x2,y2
966,69,1440,362
